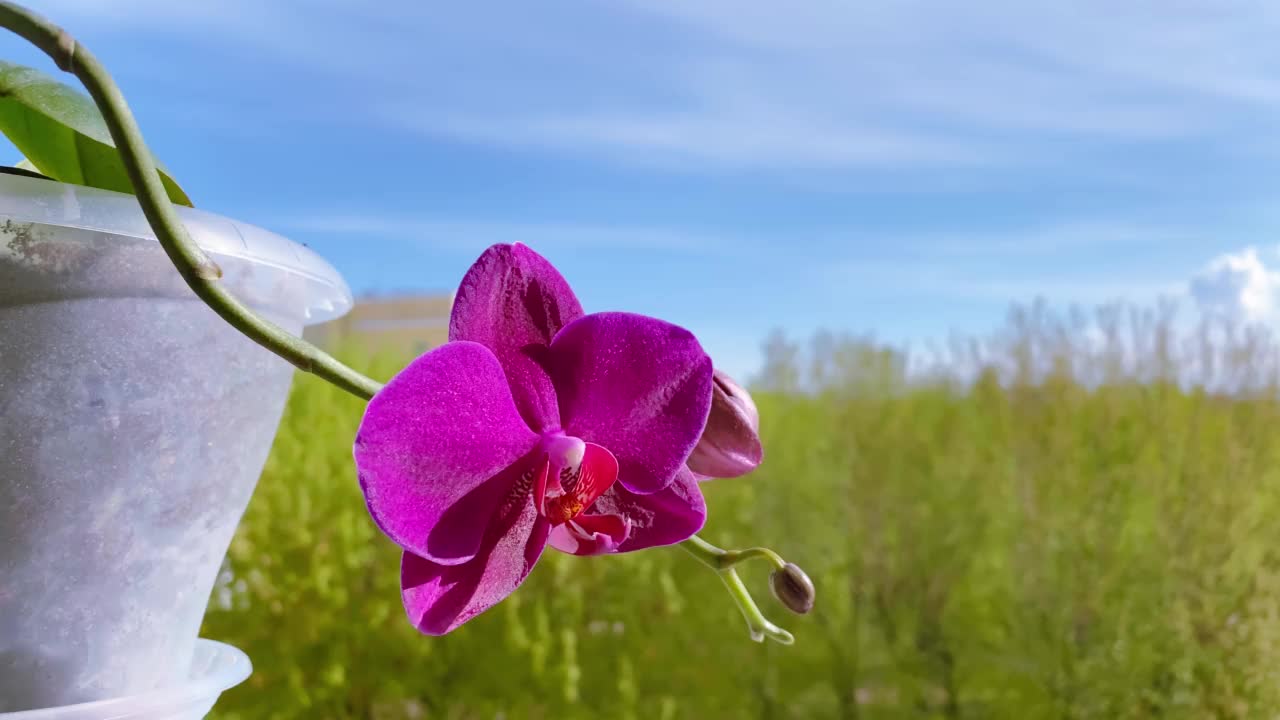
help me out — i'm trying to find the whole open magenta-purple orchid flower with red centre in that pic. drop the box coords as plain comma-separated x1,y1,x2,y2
355,245,714,634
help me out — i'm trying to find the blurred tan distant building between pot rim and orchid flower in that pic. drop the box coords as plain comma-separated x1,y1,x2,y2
302,293,453,356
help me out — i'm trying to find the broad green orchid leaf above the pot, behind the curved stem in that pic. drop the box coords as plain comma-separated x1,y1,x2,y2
0,60,191,206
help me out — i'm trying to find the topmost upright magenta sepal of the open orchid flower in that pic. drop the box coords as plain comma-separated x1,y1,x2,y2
449,243,582,432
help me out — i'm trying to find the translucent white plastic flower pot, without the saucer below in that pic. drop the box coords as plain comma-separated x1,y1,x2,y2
0,174,351,717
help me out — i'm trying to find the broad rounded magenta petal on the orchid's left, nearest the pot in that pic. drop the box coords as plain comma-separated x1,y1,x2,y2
355,342,538,565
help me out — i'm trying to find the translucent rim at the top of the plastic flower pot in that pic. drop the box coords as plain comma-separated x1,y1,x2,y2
0,173,353,325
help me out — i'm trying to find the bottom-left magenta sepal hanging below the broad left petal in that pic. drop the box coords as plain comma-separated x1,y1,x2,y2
401,495,550,635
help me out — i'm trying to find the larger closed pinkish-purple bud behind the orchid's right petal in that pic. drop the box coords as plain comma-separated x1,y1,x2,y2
689,370,764,478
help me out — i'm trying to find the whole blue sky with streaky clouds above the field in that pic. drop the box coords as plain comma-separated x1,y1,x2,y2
3,0,1280,375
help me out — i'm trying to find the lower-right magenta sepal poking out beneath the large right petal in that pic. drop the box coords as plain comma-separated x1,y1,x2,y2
583,468,707,552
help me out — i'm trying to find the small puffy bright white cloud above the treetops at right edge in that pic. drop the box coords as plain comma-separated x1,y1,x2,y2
1189,247,1280,323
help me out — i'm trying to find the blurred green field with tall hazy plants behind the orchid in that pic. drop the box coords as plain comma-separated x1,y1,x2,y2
204,302,1280,720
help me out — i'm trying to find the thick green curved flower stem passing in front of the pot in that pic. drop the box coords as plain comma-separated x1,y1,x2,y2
0,0,381,400
